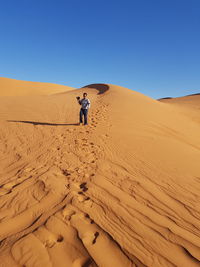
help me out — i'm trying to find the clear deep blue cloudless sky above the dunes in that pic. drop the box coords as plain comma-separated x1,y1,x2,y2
0,0,200,98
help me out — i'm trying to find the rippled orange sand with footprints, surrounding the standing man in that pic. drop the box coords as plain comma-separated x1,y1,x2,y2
0,81,200,267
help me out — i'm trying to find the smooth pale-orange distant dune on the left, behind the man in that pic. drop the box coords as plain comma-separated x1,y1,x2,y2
0,77,74,96
